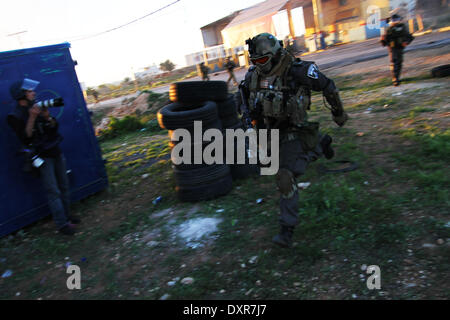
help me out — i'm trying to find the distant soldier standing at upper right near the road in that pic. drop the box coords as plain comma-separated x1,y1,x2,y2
380,8,414,86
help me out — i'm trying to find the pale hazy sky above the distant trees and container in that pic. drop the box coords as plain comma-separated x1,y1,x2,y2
0,0,262,86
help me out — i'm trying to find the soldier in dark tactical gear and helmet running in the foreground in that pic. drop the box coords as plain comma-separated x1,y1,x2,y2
241,33,347,247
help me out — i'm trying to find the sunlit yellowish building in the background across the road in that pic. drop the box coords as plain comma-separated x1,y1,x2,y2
186,0,447,69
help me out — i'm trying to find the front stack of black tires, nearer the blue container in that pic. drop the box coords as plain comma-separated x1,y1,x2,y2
158,81,256,201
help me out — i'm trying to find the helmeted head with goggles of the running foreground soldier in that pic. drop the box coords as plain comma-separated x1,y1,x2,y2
245,33,283,74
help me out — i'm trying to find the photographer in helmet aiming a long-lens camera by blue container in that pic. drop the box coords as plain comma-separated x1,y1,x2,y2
8,79,80,235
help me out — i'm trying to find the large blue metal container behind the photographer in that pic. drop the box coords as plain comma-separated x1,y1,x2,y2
0,43,108,237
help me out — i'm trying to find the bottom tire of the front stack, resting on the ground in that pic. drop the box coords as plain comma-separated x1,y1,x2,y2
176,169,233,202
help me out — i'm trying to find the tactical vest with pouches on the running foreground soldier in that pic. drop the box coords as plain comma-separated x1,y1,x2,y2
249,62,311,127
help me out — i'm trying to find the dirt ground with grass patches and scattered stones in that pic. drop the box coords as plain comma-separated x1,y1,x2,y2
0,47,450,300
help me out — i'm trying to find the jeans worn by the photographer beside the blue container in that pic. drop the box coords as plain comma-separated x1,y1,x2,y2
39,154,70,229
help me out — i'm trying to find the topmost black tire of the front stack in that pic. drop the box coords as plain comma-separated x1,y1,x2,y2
169,81,228,103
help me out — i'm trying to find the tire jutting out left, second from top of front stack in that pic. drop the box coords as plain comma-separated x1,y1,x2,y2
157,101,219,130
